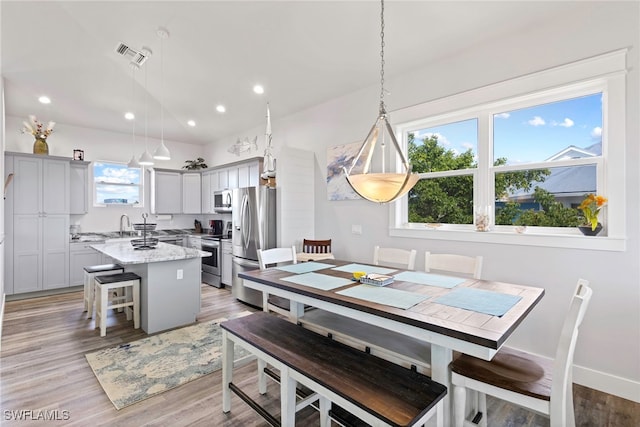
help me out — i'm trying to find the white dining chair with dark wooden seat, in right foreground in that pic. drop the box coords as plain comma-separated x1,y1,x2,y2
450,279,593,427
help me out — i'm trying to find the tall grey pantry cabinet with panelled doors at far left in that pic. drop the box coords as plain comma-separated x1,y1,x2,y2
5,153,70,293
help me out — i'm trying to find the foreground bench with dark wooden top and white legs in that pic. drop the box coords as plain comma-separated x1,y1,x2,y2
220,312,447,427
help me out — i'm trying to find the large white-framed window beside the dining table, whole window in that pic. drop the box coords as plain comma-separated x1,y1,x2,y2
390,51,626,250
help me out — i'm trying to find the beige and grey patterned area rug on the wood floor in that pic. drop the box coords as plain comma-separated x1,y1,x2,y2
85,311,251,410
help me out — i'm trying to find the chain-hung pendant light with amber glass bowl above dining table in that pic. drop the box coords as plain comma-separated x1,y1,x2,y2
343,0,418,203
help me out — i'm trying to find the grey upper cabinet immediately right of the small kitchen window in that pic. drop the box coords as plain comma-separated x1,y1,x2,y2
149,169,182,214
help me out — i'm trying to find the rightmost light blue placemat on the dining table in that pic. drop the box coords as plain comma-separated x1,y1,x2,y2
433,288,522,316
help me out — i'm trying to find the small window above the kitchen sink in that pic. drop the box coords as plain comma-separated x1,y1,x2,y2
93,162,142,206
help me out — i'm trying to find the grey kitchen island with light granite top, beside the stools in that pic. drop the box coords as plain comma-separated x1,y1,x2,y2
91,240,211,334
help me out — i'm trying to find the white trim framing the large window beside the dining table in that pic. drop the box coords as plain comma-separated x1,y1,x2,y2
389,49,627,251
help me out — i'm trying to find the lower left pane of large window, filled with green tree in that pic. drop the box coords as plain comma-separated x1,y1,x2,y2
409,175,473,224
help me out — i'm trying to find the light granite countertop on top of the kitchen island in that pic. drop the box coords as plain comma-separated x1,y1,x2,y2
91,241,212,265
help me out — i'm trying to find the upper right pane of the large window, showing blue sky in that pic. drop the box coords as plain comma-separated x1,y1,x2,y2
493,93,602,165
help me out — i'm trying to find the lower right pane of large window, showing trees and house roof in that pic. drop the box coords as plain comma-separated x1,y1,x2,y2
495,165,596,227
